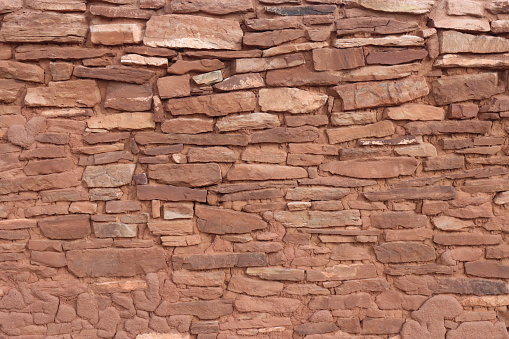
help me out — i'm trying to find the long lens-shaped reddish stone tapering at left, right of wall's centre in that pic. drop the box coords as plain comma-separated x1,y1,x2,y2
320,157,420,179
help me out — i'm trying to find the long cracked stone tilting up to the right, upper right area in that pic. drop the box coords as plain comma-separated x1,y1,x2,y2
333,76,429,110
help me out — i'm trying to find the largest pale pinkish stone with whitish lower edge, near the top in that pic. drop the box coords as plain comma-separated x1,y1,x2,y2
143,14,244,50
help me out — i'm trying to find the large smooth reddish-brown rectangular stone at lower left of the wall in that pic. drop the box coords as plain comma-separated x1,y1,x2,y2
66,247,167,278
